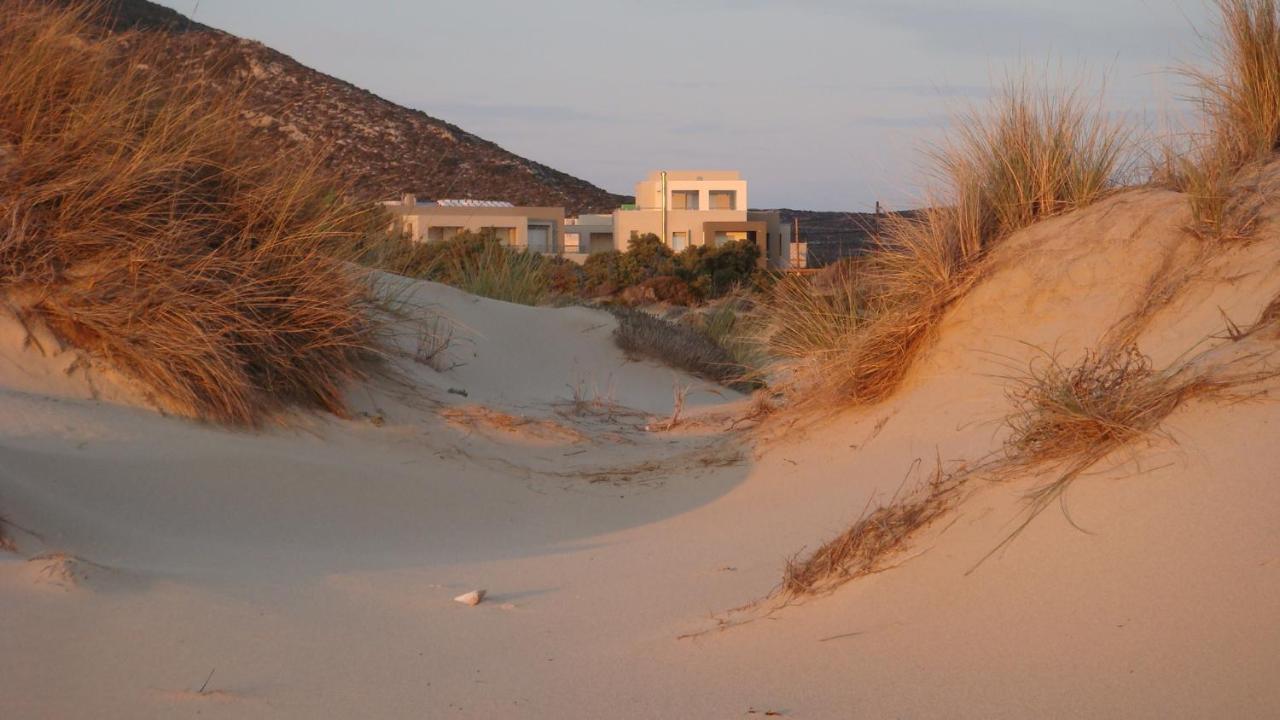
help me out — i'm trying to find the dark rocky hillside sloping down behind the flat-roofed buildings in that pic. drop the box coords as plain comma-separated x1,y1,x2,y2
70,0,627,214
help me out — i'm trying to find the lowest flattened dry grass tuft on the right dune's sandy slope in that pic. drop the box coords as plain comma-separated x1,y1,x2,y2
780,461,964,597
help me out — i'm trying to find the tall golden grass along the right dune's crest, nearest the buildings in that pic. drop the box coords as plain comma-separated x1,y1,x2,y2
773,81,1128,404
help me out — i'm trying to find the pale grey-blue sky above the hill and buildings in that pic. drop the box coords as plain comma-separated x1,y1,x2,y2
161,0,1213,210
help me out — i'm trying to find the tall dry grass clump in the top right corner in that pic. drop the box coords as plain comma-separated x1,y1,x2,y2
1156,0,1280,240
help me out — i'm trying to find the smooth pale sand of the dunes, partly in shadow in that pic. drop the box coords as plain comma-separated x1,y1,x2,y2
0,191,1280,720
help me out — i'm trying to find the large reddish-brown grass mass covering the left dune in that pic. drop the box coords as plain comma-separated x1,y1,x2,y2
0,0,376,424
